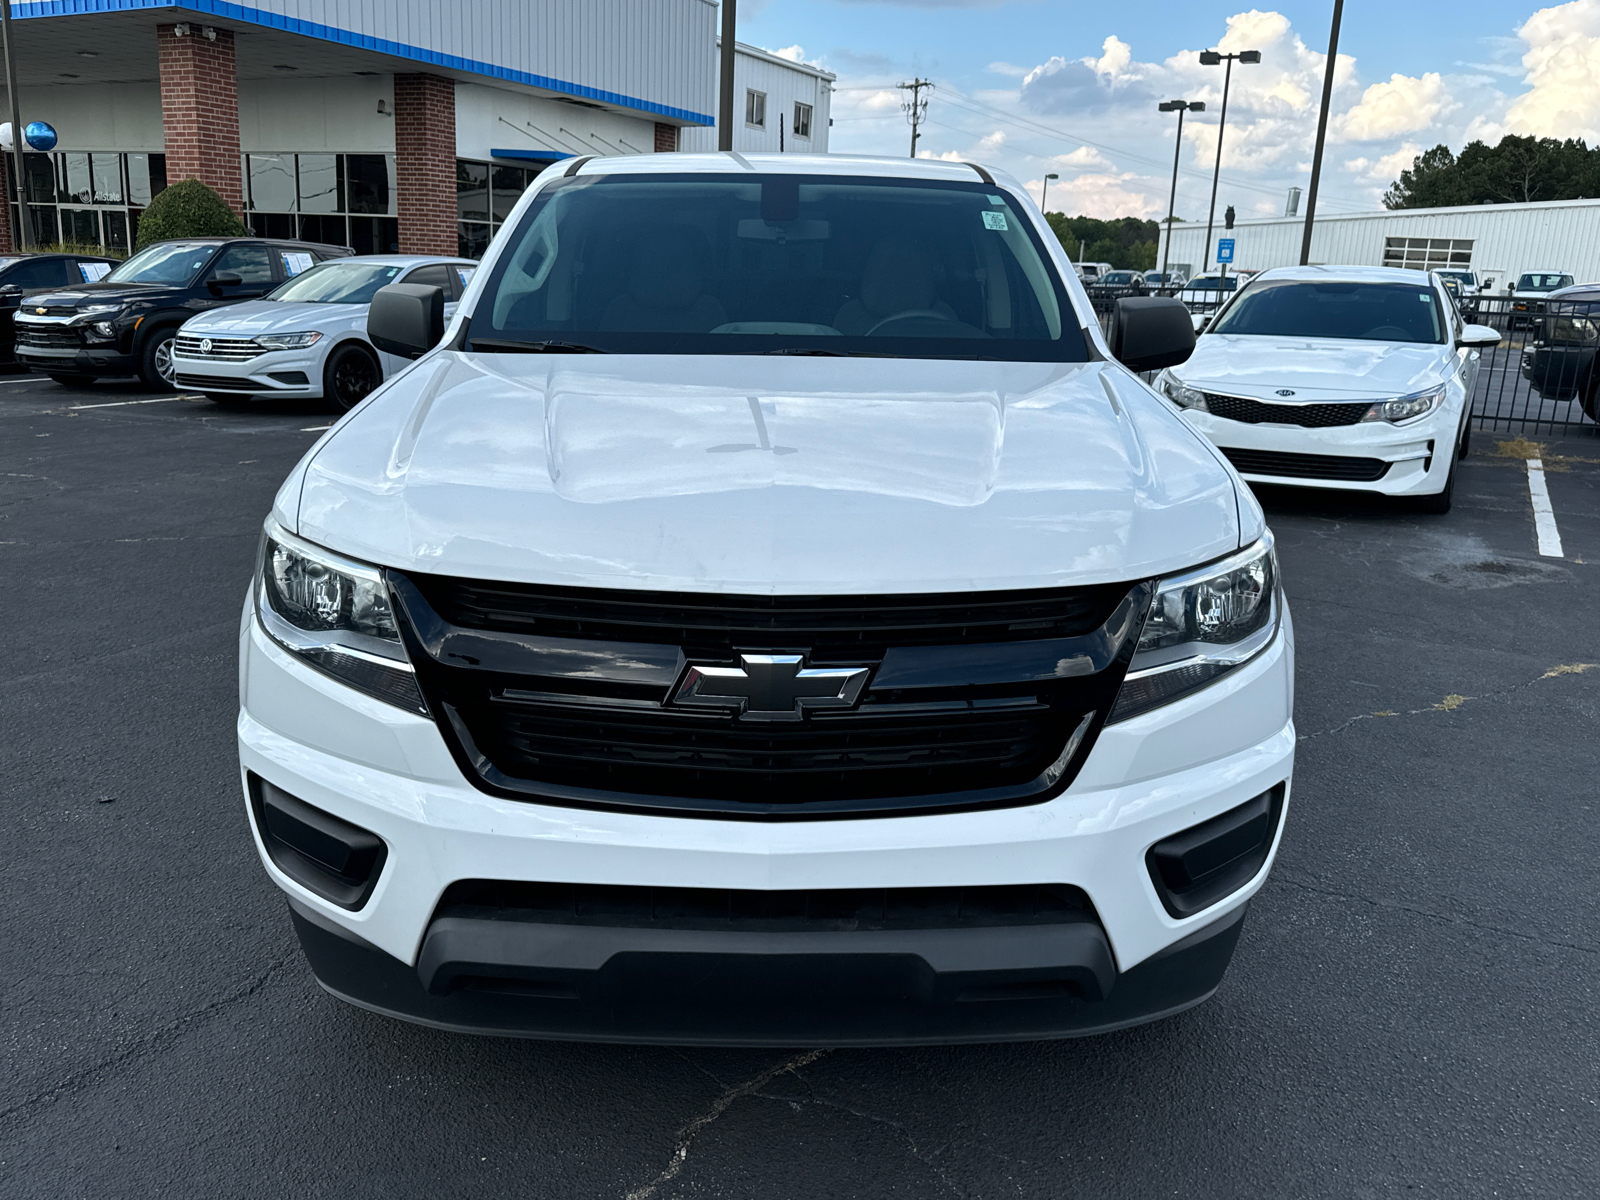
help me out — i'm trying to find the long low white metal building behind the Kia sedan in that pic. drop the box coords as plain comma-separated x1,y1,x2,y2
1157,200,1600,291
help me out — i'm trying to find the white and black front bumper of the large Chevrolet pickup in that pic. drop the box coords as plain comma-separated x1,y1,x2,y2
238,598,1294,1045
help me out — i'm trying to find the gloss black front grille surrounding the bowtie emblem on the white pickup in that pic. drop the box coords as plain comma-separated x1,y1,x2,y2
390,573,1149,818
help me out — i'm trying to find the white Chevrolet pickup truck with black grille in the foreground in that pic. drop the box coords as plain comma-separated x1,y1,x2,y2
238,154,1294,1045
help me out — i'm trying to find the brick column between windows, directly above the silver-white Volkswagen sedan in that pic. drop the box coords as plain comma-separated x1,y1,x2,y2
395,75,458,254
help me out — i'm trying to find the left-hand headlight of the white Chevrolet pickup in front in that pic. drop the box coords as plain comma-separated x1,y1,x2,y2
256,520,427,715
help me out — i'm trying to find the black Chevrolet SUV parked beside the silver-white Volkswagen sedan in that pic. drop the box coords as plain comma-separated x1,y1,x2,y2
16,237,352,390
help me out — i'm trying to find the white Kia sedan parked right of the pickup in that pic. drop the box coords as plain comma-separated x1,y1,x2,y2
1155,267,1499,512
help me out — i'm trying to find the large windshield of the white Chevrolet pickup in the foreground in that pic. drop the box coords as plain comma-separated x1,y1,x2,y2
469,173,1088,362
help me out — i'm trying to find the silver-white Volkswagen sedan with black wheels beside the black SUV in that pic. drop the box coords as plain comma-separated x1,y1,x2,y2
173,254,478,413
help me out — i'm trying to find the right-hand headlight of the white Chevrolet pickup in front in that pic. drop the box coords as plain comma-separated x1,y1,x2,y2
1107,531,1282,723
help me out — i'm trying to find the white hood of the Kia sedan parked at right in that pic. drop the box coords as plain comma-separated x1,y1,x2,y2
1173,333,1454,400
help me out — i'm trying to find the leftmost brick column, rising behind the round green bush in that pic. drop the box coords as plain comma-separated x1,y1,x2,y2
155,24,245,216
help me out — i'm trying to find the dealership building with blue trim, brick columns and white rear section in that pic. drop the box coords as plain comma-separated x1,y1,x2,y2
0,0,832,258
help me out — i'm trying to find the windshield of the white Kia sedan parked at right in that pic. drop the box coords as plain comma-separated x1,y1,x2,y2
1206,280,1445,350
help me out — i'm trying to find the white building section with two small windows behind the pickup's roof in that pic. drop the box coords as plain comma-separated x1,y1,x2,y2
678,37,835,154
